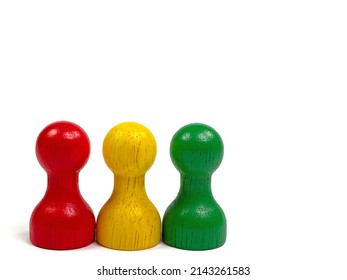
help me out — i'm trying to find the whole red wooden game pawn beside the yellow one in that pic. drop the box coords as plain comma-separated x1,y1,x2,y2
30,121,95,250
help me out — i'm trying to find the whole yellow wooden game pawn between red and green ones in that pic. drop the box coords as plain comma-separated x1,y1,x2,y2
96,122,161,250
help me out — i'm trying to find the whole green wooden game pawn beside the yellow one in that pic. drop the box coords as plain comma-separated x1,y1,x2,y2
163,123,226,250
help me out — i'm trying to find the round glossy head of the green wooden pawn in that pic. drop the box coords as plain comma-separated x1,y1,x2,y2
170,123,224,175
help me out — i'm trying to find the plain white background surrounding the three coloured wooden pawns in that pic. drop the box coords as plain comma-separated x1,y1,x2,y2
0,0,347,280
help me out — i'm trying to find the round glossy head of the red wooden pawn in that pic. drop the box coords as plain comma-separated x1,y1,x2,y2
36,121,90,175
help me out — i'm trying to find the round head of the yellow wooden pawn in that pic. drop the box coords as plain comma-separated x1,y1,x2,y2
103,122,157,176
